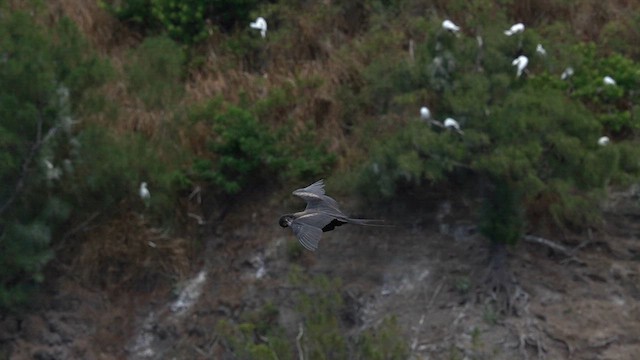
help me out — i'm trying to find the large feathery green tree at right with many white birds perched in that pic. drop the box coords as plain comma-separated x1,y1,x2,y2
355,4,640,243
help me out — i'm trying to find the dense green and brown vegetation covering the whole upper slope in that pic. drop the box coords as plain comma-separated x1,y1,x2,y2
0,0,640,358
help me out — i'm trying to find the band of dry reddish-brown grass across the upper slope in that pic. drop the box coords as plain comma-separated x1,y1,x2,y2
38,0,376,162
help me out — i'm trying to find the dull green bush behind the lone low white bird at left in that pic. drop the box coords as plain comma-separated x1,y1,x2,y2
66,127,180,219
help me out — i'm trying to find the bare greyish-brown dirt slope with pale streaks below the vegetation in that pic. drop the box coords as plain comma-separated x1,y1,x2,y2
0,188,640,359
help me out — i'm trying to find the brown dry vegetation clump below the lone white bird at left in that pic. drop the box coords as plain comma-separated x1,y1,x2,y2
71,212,193,294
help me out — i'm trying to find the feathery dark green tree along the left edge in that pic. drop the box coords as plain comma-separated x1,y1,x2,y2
0,7,107,307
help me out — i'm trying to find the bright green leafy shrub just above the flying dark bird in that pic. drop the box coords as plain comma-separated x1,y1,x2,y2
189,100,334,195
